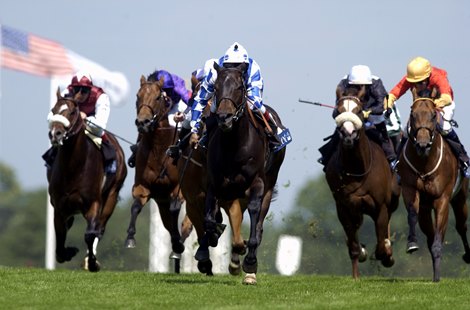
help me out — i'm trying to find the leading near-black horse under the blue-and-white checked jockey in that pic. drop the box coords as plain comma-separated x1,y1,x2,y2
200,63,286,284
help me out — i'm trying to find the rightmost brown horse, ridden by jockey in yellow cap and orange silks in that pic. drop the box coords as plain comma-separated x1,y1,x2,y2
398,89,470,282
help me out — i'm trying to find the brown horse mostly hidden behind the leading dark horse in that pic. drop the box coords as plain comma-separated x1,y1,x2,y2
178,75,246,275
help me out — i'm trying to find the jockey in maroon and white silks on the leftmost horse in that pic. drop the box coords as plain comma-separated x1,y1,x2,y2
43,71,116,173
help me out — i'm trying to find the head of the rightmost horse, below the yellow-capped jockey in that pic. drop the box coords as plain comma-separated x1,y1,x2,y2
408,88,438,156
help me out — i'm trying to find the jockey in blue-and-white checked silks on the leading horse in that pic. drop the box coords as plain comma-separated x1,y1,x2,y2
190,42,281,150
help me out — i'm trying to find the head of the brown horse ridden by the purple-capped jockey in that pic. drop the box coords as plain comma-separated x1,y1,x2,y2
135,73,172,133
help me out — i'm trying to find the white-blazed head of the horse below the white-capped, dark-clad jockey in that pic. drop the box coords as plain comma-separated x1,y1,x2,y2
335,85,366,147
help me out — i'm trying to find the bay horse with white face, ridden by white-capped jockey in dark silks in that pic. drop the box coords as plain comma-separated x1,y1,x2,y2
325,86,400,279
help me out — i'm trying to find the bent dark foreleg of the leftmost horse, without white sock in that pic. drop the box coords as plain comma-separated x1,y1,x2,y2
54,210,78,263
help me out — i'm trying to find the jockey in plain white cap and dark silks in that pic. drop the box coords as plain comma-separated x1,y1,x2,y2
318,65,396,166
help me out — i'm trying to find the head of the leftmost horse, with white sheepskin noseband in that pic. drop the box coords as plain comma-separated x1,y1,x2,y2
49,88,84,145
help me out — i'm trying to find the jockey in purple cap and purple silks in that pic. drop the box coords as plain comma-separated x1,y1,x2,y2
127,70,192,168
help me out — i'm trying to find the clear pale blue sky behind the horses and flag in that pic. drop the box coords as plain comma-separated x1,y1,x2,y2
0,0,470,219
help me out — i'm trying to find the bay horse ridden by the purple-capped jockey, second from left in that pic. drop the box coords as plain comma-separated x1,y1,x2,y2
126,72,190,260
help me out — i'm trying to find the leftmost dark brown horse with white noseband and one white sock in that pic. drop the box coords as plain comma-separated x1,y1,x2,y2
47,90,127,272
